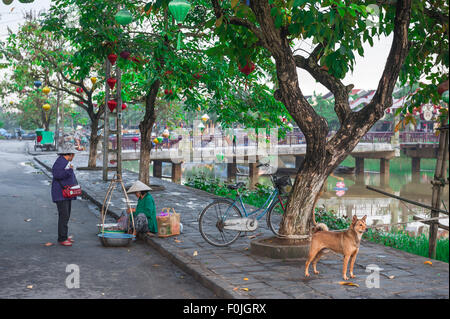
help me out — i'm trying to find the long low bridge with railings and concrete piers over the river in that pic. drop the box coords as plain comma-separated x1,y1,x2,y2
106,132,439,185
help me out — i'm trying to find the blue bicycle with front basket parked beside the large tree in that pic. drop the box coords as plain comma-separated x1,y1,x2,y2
198,164,292,247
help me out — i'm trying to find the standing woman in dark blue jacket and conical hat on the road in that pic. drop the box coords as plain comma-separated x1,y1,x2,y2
52,144,77,246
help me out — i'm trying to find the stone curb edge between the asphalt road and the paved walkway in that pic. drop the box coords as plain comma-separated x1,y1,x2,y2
33,157,243,299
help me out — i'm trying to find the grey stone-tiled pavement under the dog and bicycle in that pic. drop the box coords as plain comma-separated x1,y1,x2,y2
34,150,449,299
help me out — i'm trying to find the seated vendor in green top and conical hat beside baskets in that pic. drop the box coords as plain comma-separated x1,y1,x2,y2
127,181,158,236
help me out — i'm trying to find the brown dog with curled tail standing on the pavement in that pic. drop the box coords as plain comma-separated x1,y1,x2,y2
305,216,367,280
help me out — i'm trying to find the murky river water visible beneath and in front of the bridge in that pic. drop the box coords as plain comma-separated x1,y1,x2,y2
124,162,449,236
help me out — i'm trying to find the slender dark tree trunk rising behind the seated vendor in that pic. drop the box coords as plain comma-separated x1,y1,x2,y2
139,80,160,185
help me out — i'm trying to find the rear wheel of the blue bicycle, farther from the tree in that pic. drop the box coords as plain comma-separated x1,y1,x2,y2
198,199,242,247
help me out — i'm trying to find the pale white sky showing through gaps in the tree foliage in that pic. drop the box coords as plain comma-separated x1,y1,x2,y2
0,0,392,95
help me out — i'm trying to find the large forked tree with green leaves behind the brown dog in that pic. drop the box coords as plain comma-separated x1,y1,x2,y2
204,0,448,238
